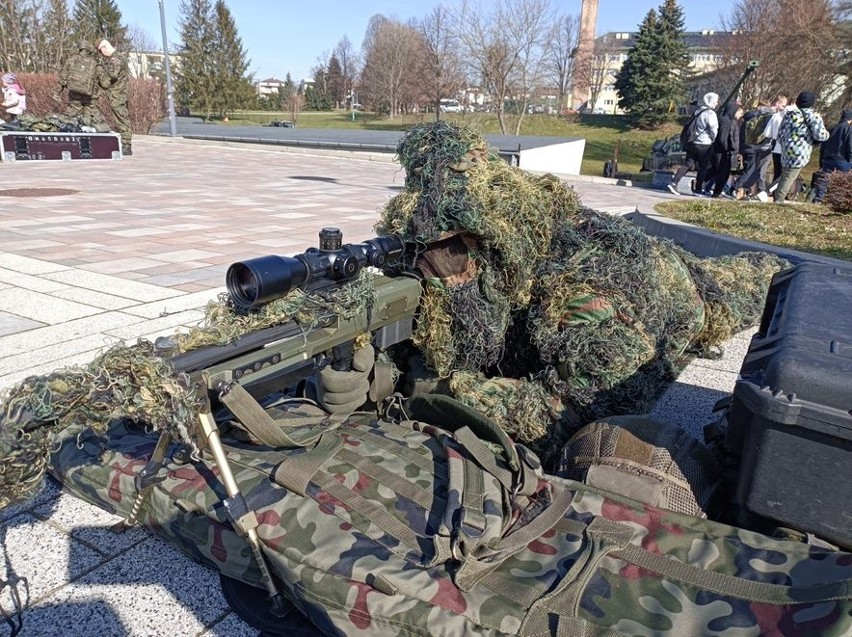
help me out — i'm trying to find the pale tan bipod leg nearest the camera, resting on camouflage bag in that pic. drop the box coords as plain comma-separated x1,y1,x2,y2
198,403,287,616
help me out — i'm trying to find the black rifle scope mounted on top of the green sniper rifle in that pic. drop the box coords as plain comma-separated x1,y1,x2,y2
225,228,405,309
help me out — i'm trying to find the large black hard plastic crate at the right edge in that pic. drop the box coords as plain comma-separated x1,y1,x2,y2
727,263,852,547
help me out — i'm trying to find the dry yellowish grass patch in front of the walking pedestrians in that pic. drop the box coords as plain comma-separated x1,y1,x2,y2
655,199,852,261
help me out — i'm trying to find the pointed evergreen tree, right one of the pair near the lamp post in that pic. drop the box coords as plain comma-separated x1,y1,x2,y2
212,0,255,115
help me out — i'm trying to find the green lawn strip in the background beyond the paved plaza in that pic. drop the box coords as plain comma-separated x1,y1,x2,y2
220,111,681,179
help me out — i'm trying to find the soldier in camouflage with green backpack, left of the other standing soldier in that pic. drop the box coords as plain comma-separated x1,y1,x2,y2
53,40,109,131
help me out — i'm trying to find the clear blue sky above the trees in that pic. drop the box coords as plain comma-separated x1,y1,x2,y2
116,0,735,80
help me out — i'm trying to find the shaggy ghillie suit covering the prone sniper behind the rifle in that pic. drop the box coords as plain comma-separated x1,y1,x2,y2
376,122,784,466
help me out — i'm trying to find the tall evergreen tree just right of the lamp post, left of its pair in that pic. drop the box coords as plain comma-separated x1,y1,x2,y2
176,0,216,119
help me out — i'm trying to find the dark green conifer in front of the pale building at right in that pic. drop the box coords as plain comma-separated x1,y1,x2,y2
615,0,689,128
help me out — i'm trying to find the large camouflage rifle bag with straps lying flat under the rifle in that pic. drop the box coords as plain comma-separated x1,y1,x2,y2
53,399,852,637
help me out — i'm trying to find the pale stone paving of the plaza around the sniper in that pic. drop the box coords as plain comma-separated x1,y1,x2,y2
0,137,748,637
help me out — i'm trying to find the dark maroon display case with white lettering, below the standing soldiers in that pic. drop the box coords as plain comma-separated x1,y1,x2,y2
0,131,121,161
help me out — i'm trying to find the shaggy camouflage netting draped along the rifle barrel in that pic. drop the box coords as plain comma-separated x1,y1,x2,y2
0,269,376,509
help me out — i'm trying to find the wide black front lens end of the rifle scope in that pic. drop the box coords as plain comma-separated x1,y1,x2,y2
225,255,308,308
